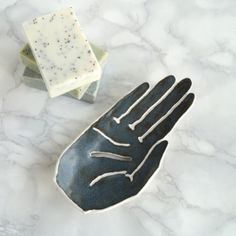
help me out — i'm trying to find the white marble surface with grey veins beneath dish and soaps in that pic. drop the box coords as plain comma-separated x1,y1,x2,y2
0,0,236,236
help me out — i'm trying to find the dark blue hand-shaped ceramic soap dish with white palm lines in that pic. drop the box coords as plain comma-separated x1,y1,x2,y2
56,76,194,211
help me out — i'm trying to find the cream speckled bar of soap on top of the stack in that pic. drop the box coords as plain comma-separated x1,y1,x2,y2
23,8,101,97
